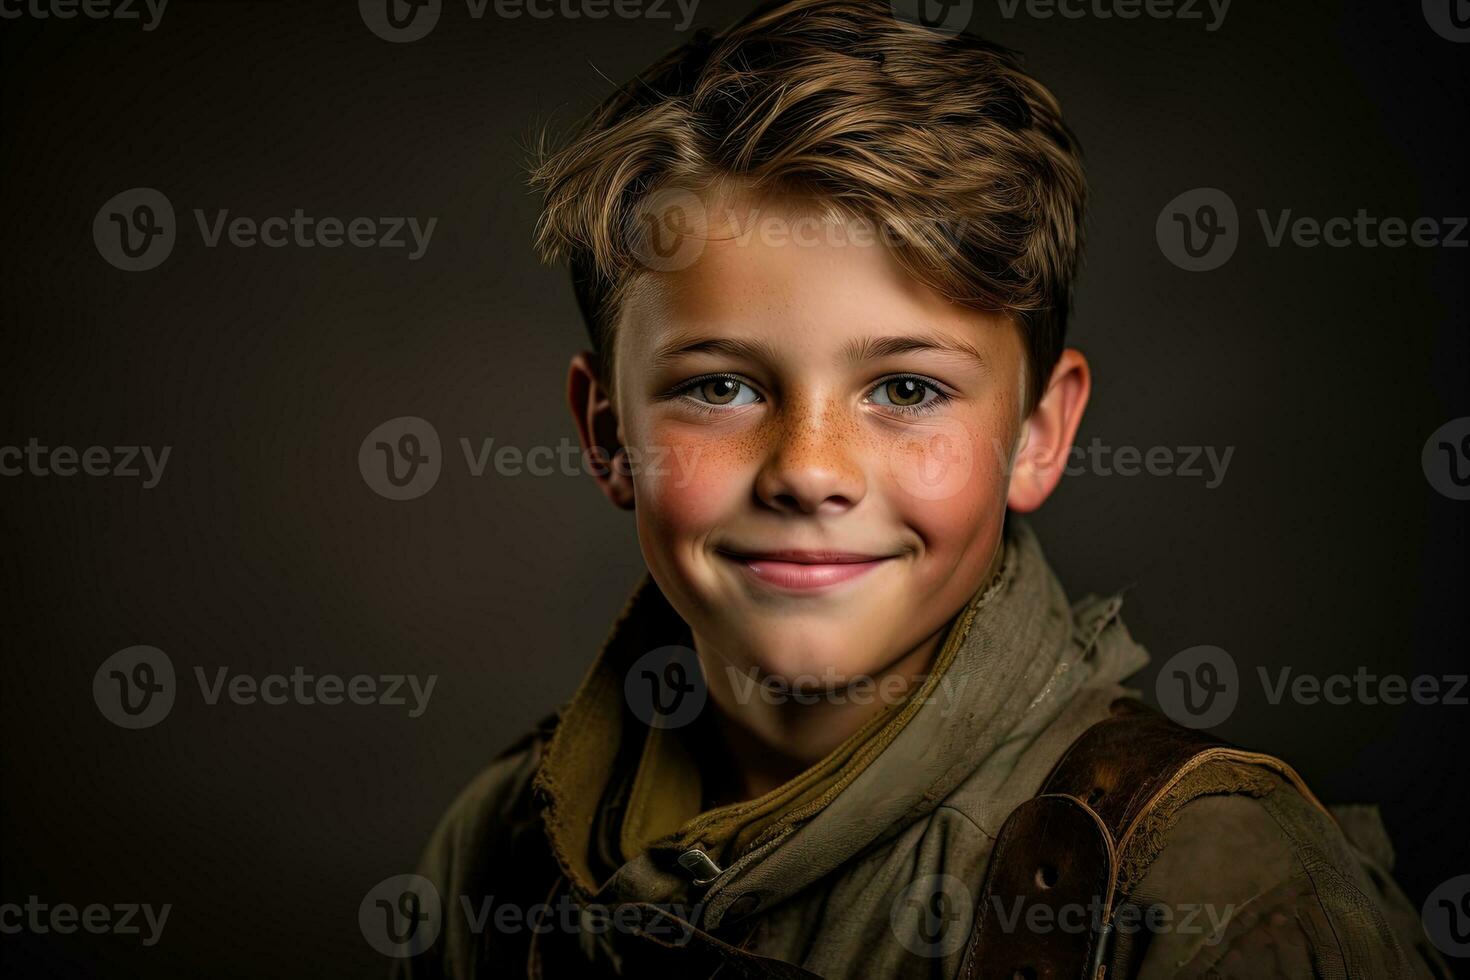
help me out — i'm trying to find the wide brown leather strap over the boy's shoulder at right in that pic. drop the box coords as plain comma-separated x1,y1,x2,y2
960,698,1322,980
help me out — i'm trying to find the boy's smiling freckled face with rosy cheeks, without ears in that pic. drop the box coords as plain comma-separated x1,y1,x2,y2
573,193,1070,688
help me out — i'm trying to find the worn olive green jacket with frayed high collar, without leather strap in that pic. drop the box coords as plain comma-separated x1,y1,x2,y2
394,517,1438,980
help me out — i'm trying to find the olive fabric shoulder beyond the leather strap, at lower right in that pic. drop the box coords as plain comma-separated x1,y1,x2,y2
1119,760,1427,977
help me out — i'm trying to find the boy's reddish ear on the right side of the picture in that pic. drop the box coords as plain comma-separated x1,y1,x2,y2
1005,347,1092,514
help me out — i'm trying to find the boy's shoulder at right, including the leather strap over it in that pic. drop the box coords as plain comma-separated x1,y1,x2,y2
1029,699,1433,977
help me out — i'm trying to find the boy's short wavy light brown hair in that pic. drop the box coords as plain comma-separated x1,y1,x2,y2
531,0,1088,410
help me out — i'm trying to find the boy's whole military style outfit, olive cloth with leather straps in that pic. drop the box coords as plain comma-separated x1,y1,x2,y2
395,517,1448,980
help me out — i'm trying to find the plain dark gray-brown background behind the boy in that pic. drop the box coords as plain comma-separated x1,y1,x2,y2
0,0,1470,977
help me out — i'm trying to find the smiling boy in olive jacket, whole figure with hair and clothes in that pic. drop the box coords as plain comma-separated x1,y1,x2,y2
400,0,1426,977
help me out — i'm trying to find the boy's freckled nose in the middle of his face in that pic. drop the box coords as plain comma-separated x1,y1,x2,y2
756,393,867,516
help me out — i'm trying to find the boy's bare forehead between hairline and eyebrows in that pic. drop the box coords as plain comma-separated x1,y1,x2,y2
617,197,1019,369
